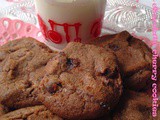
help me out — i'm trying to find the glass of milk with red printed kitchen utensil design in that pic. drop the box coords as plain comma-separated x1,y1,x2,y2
35,0,106,50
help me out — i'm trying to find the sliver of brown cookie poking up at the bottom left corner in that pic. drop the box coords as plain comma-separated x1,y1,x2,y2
0,105,63,120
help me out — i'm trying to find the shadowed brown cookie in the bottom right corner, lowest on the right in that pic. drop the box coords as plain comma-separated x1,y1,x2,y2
113,91,160,120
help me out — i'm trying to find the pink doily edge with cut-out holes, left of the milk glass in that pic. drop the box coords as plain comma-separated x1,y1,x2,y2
0,18,44,45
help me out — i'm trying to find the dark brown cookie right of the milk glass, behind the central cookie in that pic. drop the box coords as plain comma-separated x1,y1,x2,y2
90,31,152,90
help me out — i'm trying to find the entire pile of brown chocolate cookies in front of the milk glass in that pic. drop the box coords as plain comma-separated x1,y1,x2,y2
0,31,160,120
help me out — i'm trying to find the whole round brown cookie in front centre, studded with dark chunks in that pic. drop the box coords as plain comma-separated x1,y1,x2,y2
38,42,122,120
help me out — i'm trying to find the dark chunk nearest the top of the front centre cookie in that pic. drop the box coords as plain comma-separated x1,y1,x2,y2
66,58,80,70
